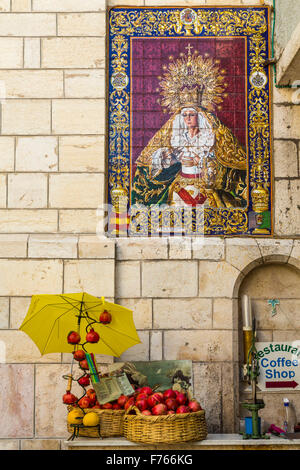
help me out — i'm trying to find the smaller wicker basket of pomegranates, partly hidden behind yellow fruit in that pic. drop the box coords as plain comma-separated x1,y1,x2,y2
68,391,128,437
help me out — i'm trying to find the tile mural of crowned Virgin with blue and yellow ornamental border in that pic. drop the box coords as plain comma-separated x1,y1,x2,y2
107,6,273,237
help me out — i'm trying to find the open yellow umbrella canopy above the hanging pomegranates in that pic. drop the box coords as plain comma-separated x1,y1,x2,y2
19,292,141,357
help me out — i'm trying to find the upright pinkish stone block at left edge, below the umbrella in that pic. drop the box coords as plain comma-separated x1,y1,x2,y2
0,364,34,438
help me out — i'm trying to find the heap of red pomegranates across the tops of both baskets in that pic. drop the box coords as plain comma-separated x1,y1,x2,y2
96,387,202,416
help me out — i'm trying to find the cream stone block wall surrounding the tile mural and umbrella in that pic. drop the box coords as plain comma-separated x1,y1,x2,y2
0,0,300,449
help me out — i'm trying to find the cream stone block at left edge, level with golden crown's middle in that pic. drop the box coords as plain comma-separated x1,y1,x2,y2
0,70,63,98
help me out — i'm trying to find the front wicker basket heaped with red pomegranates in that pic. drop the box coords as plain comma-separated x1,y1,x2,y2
124,387,207,444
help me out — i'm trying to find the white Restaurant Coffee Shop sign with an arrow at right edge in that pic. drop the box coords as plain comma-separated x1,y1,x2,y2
256,340,300,392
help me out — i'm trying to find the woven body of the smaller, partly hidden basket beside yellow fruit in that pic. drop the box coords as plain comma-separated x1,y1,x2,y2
68,406,125,437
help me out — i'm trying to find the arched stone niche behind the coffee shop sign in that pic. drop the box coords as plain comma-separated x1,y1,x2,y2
236,255,300,434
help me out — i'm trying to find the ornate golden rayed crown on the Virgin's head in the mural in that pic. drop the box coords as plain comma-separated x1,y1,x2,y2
157,44,227,112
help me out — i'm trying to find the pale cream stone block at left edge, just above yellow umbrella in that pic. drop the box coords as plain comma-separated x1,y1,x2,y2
0,259,62,296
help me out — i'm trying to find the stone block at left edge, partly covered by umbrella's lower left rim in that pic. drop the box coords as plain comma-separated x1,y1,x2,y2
0,330,61,364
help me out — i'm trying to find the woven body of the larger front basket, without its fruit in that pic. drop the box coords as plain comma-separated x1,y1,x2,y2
124,406,207,444
